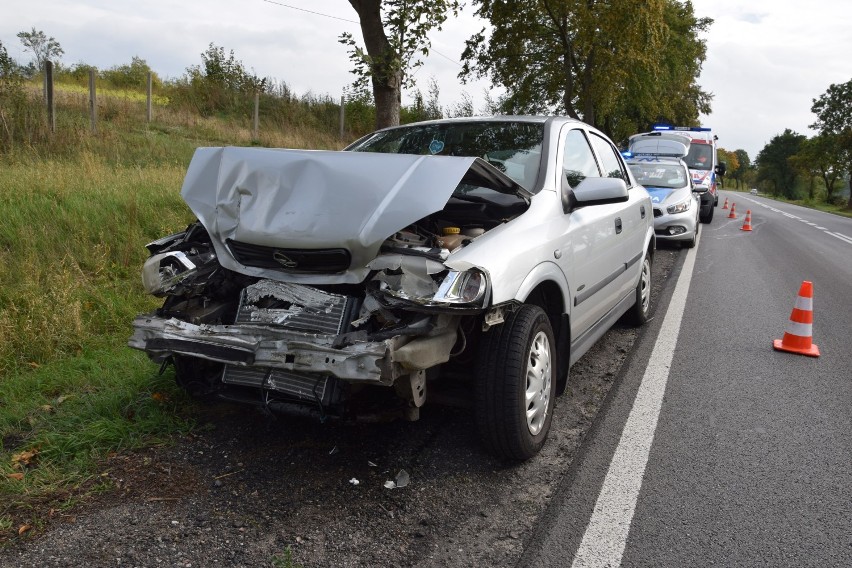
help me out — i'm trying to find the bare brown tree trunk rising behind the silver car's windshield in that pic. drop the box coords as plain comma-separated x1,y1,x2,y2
349,0,402,128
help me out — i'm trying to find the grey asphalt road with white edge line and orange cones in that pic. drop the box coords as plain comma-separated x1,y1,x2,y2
518,192,852,567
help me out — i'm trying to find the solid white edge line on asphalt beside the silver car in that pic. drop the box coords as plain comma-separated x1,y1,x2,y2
571,224,700,568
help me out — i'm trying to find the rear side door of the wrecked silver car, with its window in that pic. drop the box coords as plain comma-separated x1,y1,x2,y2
589,132,653,302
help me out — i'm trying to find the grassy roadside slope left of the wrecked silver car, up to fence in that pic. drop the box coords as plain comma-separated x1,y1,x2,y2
0,82,366,544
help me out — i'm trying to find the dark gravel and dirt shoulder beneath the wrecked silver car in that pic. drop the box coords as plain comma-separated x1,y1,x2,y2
0,249,679,567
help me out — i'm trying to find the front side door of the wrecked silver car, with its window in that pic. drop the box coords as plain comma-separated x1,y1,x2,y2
557,125,624,338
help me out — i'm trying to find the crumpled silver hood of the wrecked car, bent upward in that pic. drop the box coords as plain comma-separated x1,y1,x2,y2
181,147,524,284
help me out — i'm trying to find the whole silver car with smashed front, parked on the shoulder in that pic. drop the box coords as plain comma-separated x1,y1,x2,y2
129,117,655,459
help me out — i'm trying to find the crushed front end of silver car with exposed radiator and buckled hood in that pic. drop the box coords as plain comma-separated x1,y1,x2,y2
129,149,526,419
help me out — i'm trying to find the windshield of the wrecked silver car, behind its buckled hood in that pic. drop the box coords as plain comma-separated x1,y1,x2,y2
347,121,544,191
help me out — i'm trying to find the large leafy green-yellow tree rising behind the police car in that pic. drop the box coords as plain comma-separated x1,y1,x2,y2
460,0,712,140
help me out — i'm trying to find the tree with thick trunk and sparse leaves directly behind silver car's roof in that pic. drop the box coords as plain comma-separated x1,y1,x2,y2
340,0,461,128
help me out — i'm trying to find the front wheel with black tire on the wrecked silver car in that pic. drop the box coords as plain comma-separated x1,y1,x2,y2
475,305,556,460
